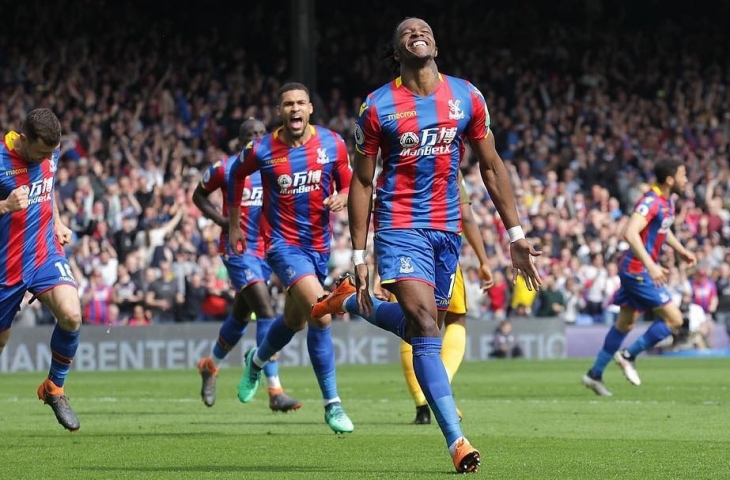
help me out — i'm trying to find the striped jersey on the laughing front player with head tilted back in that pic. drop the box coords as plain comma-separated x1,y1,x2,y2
355,74,489,233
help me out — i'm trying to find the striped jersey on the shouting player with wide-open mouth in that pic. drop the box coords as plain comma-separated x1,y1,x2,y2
228,125,352,253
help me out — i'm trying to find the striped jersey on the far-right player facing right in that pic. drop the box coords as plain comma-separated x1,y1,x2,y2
619,186,674,275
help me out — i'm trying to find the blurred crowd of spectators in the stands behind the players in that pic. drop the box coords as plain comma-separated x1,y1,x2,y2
0,0,730,346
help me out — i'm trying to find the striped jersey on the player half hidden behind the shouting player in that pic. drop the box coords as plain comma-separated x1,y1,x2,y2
200,155,266,258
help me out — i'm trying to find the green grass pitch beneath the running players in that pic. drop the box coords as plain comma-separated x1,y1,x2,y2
0,358,730,480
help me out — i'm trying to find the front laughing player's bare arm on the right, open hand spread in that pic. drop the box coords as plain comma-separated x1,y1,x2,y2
470,131,542,290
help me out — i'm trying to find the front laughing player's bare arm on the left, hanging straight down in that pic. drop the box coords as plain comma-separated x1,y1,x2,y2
347,152,375,315
